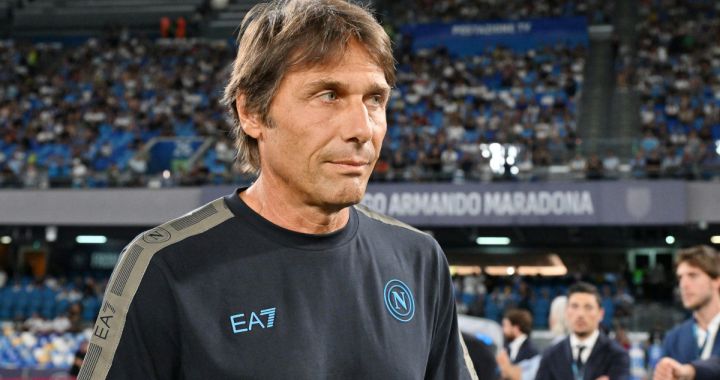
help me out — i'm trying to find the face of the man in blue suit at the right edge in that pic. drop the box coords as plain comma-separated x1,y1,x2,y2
675,262,720,311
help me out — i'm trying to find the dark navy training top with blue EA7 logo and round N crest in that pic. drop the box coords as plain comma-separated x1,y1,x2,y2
78,190,475,380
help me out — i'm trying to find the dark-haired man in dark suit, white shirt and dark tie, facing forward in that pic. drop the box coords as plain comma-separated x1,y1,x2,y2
536,282,630,380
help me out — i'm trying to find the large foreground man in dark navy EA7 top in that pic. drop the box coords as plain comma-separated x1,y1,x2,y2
79,0,476,379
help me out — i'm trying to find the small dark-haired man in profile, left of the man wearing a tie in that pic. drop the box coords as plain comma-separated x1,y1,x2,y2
502,309,539,364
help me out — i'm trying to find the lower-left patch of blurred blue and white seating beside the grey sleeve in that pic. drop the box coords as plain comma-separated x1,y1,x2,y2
0,271,102,370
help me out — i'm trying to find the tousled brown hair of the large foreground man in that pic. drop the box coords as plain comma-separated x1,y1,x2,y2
222,0,395,173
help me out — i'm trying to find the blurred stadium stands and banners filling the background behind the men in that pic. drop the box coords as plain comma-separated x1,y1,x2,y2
0,0,720,380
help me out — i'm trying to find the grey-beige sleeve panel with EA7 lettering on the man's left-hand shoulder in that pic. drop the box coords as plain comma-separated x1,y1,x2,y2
78,198,233,380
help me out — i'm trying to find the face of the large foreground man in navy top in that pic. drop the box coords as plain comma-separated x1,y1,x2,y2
253,40,390,210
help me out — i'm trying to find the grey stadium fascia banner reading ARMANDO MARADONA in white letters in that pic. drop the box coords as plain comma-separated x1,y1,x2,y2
362,181,687,227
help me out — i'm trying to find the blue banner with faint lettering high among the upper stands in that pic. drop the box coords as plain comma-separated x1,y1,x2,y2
402,17,588,56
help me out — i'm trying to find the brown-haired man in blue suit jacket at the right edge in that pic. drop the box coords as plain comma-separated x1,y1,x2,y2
663,246,720,364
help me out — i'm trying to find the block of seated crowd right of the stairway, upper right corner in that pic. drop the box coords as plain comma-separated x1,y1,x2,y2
616,0,720,179
